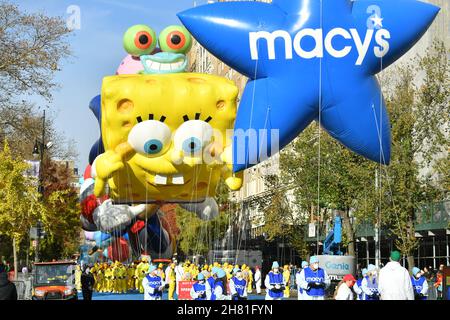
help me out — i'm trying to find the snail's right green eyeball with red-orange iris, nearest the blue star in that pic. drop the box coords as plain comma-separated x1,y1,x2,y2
158,26,192,53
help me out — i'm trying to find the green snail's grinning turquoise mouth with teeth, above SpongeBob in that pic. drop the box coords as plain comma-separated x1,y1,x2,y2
141,52,188,74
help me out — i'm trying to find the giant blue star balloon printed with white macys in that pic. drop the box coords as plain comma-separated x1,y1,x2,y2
178,0,439,172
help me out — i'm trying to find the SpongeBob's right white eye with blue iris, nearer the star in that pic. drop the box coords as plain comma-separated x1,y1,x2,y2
173,120,213,156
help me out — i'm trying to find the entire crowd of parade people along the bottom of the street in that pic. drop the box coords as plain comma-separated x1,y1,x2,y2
0,251,444,300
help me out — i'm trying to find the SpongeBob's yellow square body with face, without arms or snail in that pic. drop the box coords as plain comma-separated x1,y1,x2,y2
97,73,238,203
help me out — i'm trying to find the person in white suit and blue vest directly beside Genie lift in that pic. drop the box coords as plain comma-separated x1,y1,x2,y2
299,256,331,300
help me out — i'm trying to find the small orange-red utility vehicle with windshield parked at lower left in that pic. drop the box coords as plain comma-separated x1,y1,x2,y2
32,261,78,300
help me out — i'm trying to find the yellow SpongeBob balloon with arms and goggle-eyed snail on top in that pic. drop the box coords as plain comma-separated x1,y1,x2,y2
89,25,242,203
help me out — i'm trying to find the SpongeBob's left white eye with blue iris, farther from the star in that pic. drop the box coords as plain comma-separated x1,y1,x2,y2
128,120,171,156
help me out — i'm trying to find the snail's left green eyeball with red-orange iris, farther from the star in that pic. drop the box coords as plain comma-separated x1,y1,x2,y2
123,24,156,57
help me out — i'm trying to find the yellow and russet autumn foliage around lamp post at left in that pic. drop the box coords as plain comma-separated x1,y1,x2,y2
0,141,81,276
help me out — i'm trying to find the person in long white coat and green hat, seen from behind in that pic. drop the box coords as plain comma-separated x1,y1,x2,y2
378,251,414,300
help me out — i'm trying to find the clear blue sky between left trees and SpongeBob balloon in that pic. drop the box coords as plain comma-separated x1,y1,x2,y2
12,0,213,172
